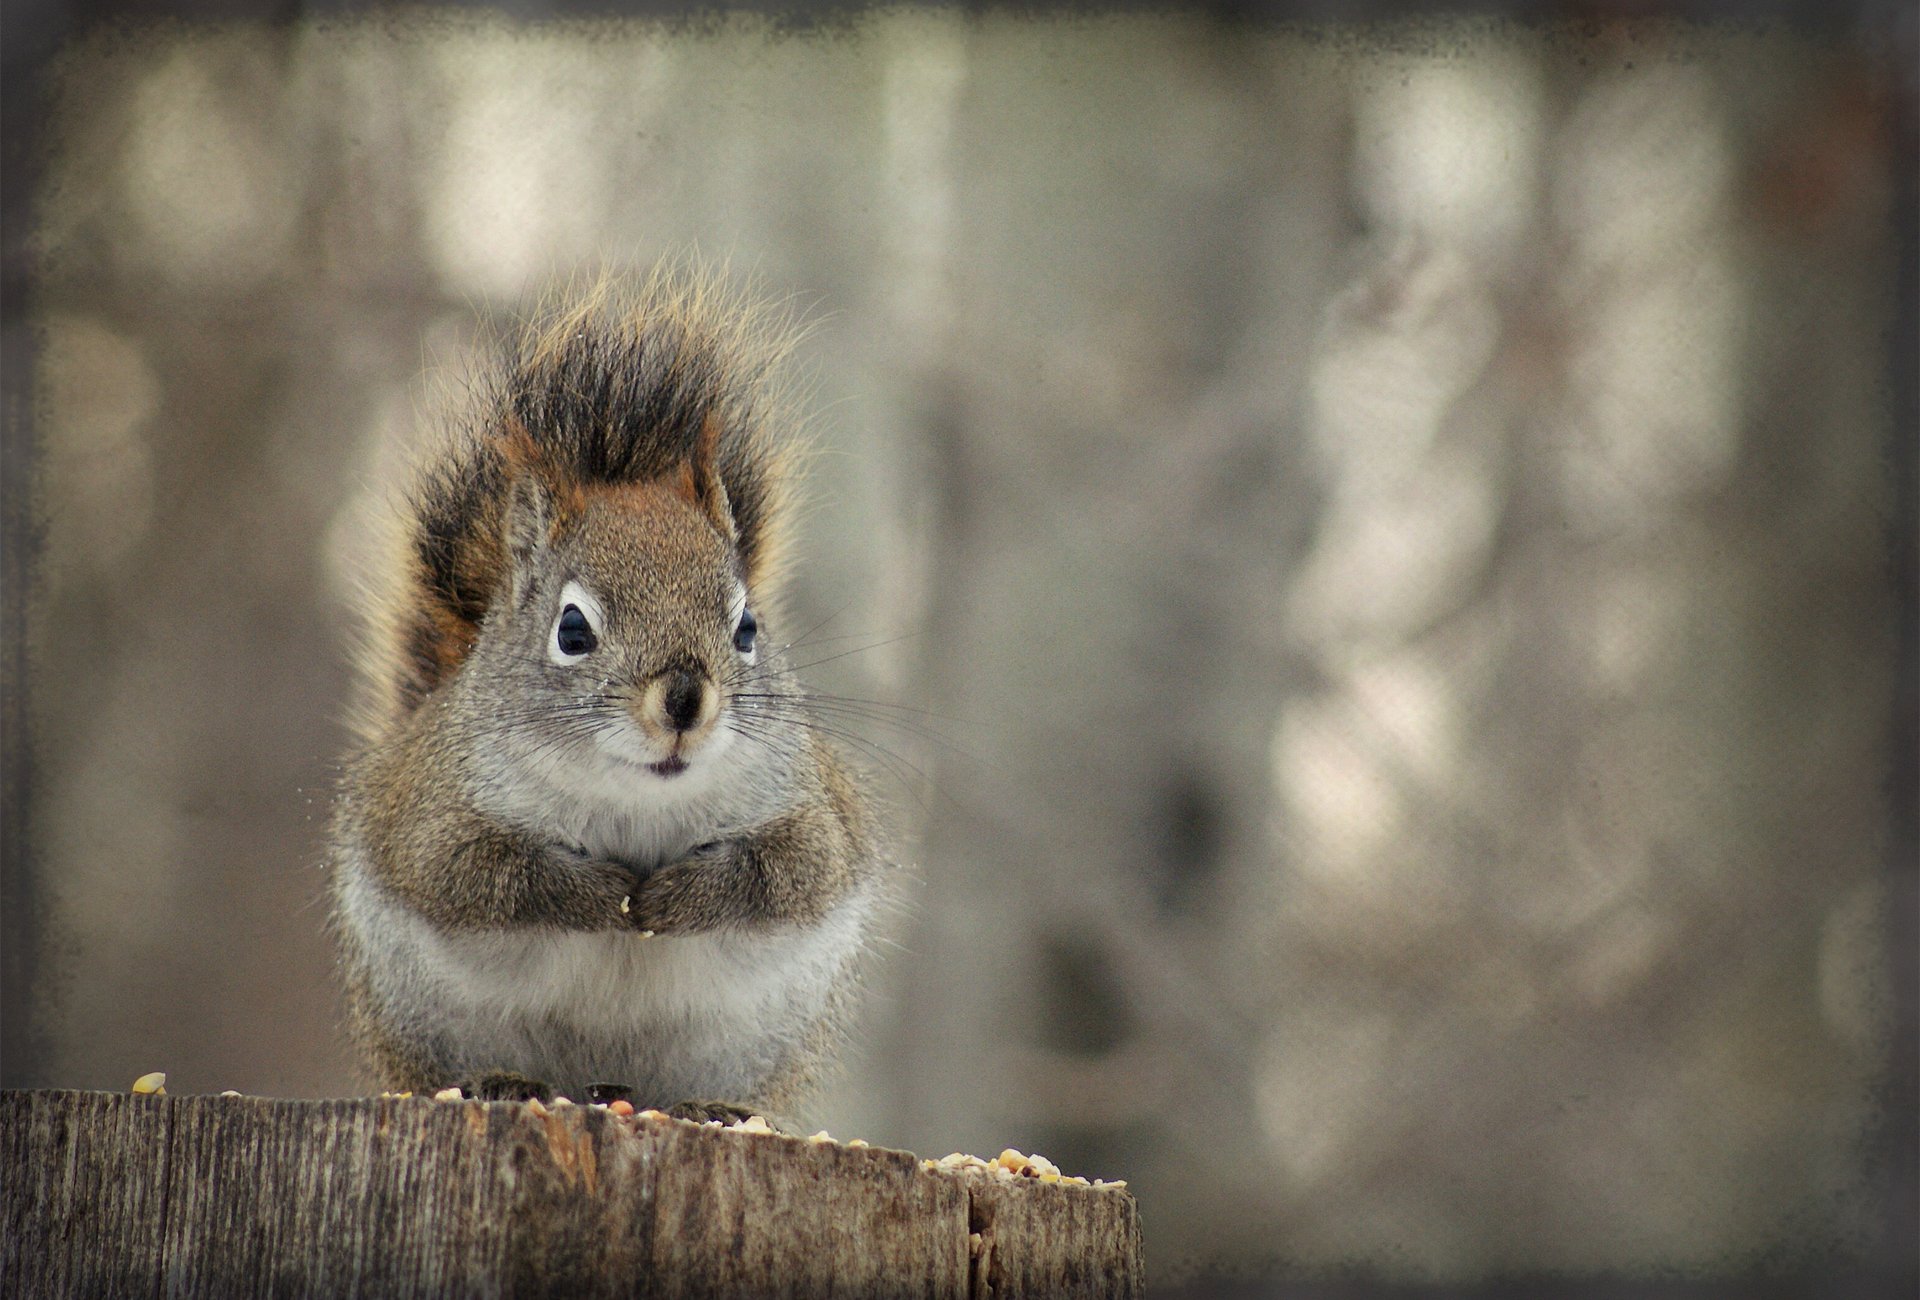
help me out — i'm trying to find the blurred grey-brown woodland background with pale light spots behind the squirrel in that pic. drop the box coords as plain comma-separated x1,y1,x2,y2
0,10,1914,1281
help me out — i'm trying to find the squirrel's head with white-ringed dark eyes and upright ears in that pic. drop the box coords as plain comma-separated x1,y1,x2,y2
474,421,772,793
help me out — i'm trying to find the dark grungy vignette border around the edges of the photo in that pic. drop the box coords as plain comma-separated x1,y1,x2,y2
0,0,1920,1300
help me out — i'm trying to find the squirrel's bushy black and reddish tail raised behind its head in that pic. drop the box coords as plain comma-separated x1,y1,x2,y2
361,269,795,735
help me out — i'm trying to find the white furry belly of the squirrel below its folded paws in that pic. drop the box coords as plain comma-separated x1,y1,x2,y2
344,867,870,1106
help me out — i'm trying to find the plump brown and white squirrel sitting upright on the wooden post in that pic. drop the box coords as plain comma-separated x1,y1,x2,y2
328,269,889,1119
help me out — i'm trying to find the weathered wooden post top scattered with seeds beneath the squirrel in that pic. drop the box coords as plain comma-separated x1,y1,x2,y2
0,1091,1140,1296
